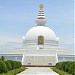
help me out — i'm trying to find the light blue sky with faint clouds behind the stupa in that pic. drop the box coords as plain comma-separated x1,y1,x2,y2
0,0,75,53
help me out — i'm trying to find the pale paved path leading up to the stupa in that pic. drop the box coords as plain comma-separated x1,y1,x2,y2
17,67,59,75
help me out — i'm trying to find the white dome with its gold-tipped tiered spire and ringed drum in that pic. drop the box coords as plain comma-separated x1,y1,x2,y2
23,4,59,46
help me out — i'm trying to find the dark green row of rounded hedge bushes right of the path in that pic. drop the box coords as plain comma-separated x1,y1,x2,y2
55,61,75,75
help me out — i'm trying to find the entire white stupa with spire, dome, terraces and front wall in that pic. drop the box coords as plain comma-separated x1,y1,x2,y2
8,4,70,66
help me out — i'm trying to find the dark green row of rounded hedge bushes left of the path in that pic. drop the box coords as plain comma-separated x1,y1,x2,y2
0,60,22,73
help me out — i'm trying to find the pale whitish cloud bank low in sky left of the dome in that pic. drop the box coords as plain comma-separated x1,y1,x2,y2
0,35,22,53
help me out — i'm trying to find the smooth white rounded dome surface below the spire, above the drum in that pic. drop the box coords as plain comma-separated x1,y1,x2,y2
25,26,57,41
